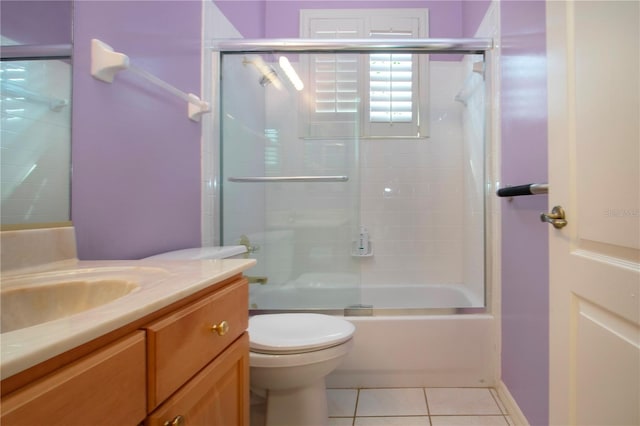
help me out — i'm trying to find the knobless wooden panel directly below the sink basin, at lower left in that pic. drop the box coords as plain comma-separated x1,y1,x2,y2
2,331,146,426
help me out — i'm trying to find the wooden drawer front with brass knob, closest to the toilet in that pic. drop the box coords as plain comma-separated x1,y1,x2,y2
145,279,249,411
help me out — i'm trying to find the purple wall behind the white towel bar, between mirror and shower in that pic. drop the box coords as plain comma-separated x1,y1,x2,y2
72,0,202,259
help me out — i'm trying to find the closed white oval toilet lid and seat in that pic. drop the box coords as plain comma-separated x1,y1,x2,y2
249,314,355,354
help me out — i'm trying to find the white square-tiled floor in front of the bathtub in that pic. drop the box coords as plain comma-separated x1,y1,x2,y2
327,388,512,426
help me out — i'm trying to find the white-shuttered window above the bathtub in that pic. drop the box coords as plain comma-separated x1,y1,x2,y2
300,9,428,138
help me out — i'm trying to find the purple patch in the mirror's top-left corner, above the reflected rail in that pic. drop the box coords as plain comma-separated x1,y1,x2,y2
0,0,72,44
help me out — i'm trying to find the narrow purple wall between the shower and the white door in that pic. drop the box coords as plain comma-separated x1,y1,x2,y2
500,1,549,426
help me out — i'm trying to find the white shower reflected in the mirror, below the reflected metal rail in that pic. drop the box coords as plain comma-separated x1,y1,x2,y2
0,60,71,224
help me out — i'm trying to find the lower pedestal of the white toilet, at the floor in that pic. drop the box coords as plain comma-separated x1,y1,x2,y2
265,378,329,426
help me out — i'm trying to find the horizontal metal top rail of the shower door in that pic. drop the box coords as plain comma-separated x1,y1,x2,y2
206,38,493,54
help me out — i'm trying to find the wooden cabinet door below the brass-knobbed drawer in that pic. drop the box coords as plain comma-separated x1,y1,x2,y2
145,333,249,426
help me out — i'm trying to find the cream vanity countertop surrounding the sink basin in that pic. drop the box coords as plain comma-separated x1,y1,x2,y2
0,259,256,379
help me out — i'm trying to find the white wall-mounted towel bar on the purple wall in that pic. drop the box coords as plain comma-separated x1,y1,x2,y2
91,38,211,121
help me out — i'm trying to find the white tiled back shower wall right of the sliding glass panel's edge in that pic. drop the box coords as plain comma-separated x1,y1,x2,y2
360,62,464,285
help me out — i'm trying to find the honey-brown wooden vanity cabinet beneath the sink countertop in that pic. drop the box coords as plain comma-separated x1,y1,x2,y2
0,275,249,426
